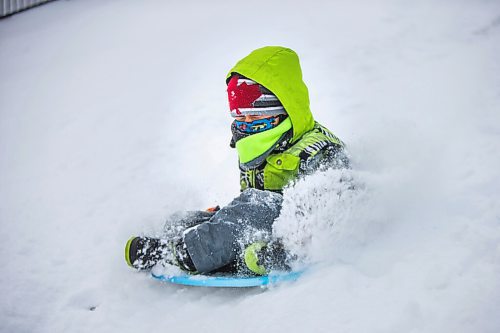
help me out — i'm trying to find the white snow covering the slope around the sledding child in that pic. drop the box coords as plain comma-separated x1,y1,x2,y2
0,0,500,332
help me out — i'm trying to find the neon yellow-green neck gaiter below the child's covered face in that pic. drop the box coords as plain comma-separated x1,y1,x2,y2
236,117,292,164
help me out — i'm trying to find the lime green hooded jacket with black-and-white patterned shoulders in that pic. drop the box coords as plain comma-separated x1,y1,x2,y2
226,46,343,191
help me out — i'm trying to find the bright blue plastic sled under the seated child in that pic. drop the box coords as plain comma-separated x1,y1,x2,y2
151,271,304,288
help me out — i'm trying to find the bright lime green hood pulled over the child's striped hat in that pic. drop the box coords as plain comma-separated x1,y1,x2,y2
226,46,314,142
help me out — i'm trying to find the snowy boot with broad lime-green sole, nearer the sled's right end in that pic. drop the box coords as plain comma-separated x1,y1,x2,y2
243,242,290,275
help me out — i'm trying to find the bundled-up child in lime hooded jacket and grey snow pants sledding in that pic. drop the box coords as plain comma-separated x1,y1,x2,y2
125,46,349,275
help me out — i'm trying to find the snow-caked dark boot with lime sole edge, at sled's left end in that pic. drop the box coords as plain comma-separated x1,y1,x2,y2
125,237,196,272
